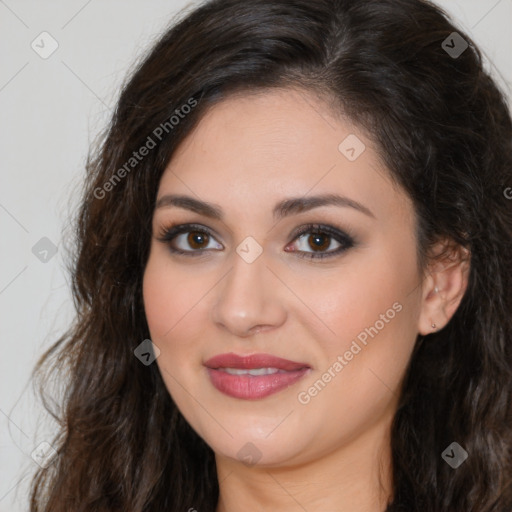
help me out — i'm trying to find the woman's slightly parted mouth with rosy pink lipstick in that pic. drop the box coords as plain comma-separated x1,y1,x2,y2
204,353,311,400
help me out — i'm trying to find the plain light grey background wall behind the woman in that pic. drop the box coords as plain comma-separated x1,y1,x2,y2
0,0,512,512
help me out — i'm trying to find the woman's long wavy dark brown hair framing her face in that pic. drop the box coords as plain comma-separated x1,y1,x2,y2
30,0,512,512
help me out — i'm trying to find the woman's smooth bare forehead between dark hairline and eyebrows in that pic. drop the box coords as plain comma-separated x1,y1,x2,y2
159,89,411,222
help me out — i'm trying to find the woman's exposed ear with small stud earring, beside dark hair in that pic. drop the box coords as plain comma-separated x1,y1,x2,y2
418,239,471,335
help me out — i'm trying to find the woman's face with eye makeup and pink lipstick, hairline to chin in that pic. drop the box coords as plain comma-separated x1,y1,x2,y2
144,90,428,466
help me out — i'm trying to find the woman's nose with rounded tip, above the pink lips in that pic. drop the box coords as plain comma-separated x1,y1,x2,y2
212,246,286,338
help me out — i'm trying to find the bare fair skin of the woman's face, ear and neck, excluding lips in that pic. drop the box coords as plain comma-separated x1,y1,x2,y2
143,88,469,512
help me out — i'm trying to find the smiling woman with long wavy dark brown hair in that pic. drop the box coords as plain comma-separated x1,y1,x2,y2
31,0,512,512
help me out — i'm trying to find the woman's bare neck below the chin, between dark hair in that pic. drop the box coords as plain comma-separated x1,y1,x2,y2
216,416,392,512
